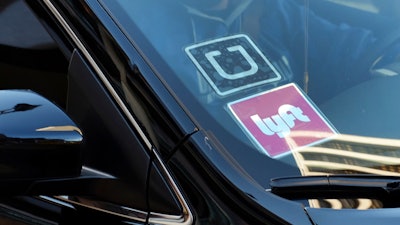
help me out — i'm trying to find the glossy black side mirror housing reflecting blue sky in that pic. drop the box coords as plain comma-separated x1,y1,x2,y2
0,90,83,180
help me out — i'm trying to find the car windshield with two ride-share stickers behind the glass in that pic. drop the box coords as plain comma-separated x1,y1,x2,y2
99,0,400,209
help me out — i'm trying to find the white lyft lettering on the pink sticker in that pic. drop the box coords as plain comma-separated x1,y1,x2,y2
250,104,311,138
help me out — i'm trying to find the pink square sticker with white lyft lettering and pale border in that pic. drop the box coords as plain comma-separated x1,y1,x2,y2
228,83,336,157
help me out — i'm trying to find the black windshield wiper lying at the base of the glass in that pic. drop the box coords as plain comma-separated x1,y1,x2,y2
270,175,400,202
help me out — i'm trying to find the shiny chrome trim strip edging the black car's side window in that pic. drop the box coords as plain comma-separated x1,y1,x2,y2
42,0,193,225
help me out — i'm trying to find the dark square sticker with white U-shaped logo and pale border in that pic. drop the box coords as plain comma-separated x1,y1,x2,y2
185,34,281,95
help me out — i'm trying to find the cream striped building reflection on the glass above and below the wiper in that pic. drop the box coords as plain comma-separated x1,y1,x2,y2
293,132,400,209
